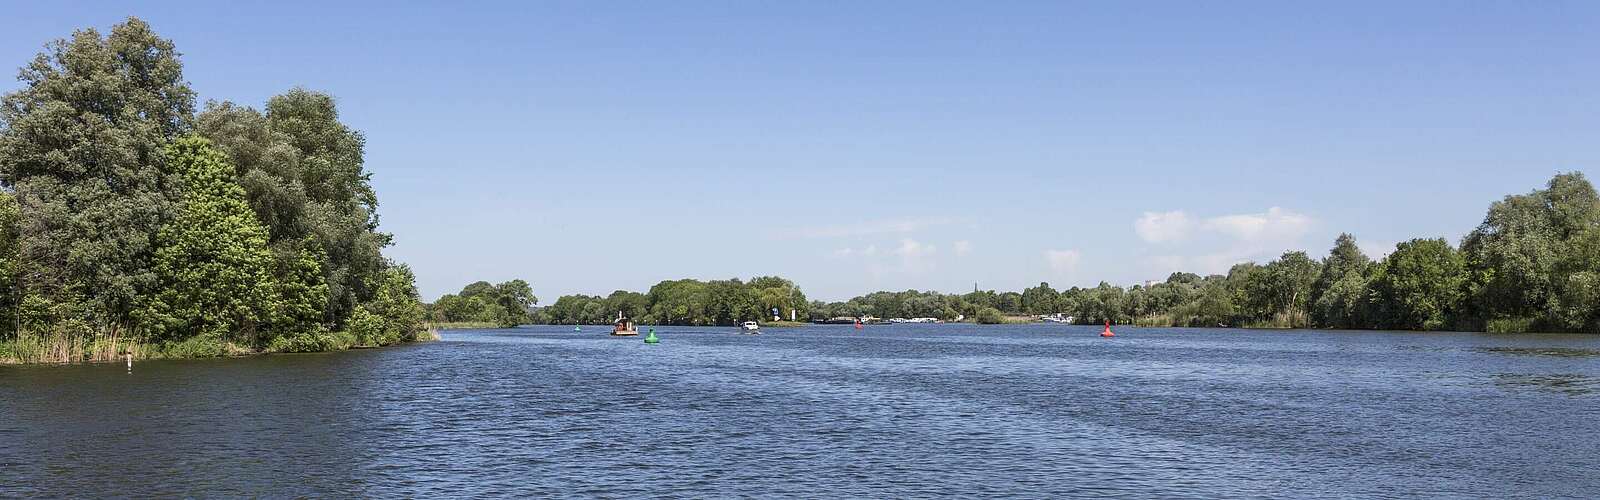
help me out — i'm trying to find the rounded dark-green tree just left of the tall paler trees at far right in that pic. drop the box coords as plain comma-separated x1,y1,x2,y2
1373,239,1467,330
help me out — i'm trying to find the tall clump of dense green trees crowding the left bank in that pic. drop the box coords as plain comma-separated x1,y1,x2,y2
0,18,422,358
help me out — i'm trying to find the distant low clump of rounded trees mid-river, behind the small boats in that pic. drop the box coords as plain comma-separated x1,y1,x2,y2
536,276,811,325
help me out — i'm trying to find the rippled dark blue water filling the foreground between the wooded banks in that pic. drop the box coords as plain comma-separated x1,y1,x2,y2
0,325,1600,498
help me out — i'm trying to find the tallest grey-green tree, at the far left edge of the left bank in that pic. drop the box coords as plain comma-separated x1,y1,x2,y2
0,18,194,332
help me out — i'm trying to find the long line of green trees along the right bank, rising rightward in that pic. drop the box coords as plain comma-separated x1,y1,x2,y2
810,173,1600,333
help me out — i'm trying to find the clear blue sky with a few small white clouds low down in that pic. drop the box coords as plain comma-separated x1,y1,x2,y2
0,2,1600,301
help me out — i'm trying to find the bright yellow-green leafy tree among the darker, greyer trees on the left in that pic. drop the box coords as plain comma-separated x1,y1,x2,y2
141,136,282,345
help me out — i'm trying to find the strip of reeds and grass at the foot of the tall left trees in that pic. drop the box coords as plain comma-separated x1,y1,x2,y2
0,329,440,365
